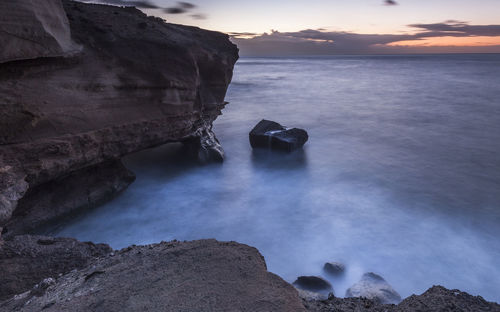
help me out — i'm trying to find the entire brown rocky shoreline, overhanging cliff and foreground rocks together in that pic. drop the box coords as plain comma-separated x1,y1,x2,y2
0,0,500,311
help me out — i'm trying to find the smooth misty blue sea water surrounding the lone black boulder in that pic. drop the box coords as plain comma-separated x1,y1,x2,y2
50,55,500,301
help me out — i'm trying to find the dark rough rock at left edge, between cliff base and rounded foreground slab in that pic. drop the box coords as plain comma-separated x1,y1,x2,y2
0,235,112,300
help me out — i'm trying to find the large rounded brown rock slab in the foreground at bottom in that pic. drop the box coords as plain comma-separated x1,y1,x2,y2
0,240,305,312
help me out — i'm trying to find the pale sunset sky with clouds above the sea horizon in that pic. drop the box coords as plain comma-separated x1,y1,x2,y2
81,0,500,56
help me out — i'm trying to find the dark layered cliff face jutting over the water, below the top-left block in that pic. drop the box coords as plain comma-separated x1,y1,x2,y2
0,0,238,233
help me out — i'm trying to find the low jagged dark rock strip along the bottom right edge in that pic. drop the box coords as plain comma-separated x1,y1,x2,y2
304,286,500,312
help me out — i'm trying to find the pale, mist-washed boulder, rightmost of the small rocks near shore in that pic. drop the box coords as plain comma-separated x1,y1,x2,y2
345,273,401,304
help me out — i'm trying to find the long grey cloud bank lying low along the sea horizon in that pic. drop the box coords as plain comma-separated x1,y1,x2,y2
229,21,500,55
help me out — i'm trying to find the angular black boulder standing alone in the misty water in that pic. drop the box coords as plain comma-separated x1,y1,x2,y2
249,120,309,152
